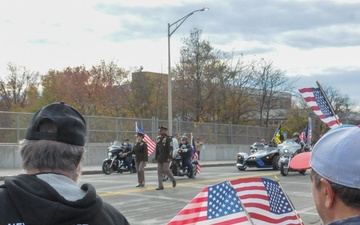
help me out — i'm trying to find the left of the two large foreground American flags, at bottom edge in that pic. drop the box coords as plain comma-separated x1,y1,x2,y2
168,181,253,225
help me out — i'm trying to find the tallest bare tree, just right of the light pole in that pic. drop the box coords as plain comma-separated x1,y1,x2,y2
172,28,219,121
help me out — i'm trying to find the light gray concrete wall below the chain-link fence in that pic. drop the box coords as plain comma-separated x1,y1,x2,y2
0,143,250,169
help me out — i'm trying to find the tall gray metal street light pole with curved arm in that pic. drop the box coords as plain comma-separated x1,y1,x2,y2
168,7,209,135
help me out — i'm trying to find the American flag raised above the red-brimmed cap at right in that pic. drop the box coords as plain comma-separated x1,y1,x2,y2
299,88,341,128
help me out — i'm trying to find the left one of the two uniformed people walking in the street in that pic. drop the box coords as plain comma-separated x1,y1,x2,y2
124,132,148,187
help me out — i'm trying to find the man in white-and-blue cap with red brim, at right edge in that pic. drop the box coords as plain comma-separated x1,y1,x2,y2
290,125,360,225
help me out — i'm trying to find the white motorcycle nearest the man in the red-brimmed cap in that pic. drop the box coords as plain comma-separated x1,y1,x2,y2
278,139,306,176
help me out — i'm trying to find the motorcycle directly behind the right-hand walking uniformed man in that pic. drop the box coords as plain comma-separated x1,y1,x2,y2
170,145,198,177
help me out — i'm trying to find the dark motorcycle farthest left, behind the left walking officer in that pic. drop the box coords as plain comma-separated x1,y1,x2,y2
102,141,136,175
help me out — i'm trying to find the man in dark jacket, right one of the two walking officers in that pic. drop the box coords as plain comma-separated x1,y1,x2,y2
155,126,176,190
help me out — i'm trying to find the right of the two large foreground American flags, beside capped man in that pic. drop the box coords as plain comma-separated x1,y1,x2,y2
230,178,304,225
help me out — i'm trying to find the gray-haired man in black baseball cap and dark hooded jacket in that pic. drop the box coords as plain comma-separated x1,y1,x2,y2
0,102,129,225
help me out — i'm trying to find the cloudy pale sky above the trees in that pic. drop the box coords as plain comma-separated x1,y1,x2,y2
0,0,360,109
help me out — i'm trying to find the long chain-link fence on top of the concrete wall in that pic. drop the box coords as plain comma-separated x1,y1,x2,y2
0,112,276,145
